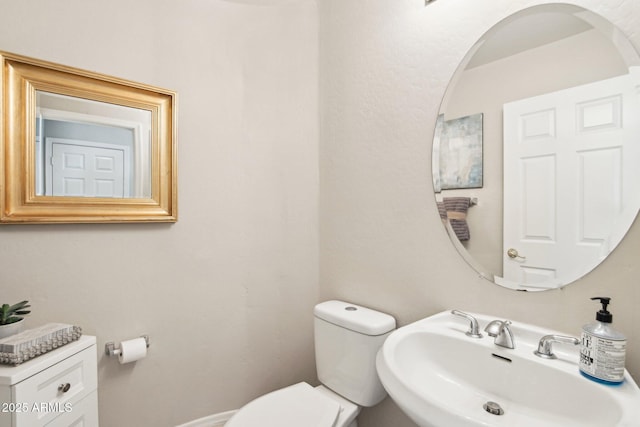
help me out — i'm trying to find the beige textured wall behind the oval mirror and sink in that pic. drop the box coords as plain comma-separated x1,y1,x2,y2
319,0,640,427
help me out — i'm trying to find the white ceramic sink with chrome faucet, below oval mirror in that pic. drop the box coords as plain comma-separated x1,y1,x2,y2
376,311,640,427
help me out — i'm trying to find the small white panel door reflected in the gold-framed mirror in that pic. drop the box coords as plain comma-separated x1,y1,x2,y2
45,138,131,197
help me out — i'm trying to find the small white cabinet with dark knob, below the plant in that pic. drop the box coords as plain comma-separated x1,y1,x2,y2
0,336,98,427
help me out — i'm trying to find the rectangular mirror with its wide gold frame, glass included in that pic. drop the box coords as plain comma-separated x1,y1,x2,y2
0,52,177,223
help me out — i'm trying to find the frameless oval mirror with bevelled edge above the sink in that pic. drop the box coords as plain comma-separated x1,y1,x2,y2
433,4,640,291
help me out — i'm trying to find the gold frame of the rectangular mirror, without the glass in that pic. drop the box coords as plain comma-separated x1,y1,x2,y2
0,52,178,224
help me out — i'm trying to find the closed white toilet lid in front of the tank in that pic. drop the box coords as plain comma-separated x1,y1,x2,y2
225,382,341,427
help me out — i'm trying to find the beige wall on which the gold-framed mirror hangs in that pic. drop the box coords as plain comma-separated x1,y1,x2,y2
0,0,318,427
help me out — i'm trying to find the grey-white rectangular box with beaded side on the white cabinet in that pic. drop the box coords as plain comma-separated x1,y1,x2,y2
0,323,82,365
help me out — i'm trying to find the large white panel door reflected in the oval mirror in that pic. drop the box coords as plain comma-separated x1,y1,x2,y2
503,73,640,289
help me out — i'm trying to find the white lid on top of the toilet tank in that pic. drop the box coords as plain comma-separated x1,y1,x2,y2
313,300,396,335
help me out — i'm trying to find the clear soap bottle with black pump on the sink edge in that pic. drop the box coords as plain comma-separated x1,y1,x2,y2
579,297,627,385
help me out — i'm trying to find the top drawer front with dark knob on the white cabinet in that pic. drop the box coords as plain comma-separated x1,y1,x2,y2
12,345,98,426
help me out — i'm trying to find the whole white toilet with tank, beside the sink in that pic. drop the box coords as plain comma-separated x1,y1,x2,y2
225,301,396,427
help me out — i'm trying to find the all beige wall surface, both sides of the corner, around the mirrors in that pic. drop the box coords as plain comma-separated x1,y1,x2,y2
0,0,640,427
